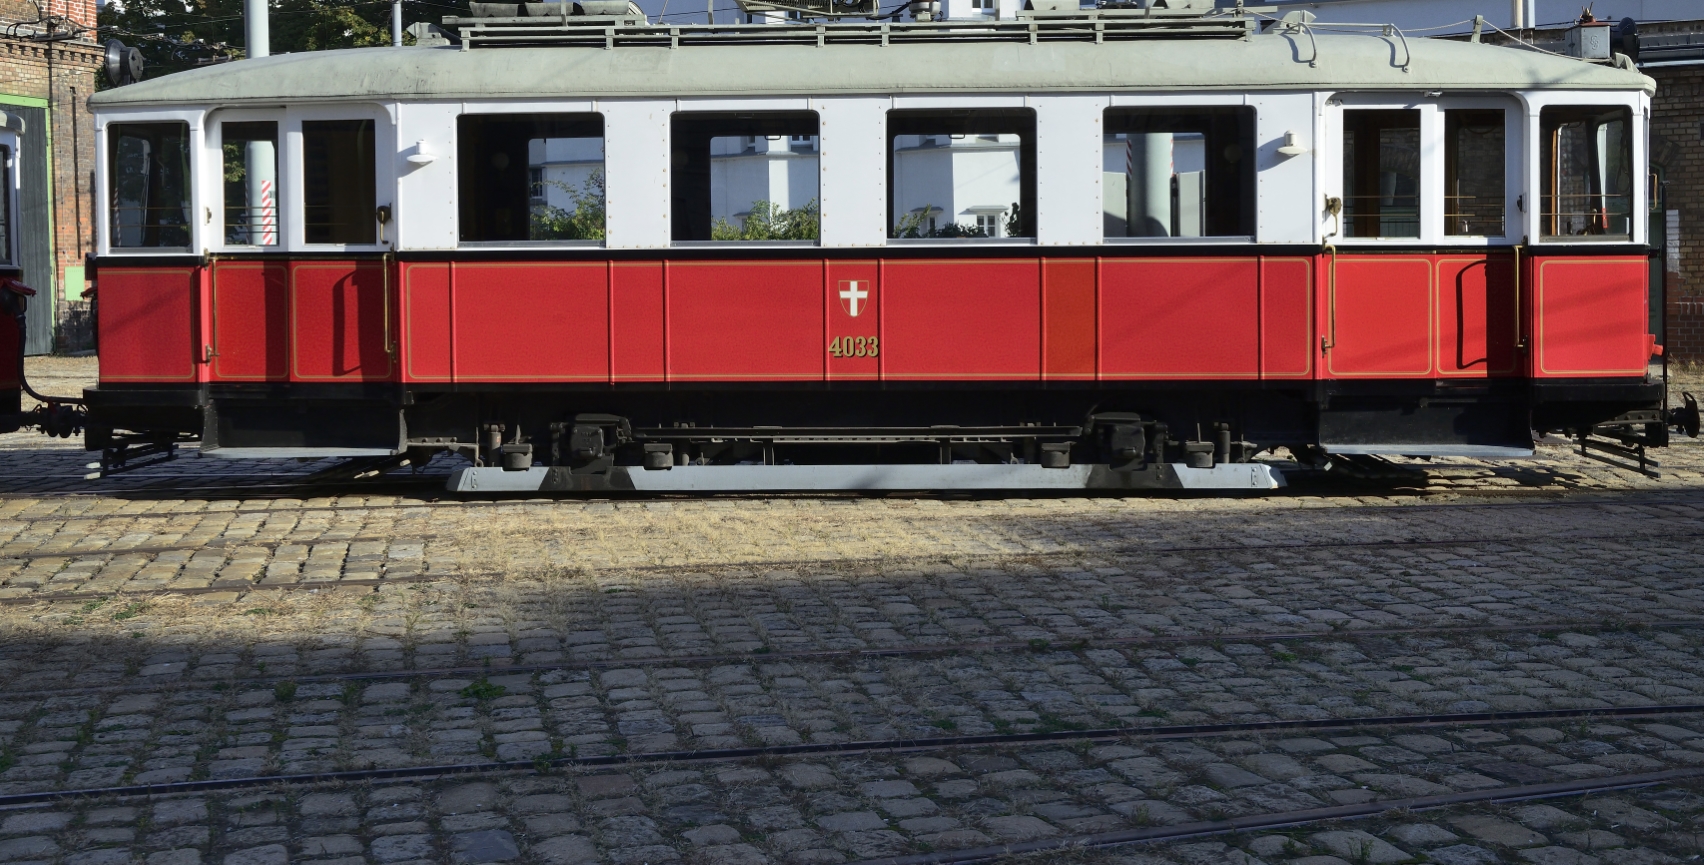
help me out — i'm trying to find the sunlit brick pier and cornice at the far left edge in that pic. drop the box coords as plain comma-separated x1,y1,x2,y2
0,33,102,351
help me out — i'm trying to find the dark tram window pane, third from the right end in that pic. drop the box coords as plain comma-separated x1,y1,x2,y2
1343,109,1419,237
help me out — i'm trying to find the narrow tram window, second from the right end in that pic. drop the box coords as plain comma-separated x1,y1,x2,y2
1443,109,1505,237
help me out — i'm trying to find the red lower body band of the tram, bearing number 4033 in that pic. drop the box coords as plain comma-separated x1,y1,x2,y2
99,252,1651,385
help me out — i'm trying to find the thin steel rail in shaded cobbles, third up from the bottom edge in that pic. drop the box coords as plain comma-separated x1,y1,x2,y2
0,618,1704,700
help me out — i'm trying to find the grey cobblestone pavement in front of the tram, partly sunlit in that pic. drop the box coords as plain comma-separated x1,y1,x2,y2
10,361,1704,865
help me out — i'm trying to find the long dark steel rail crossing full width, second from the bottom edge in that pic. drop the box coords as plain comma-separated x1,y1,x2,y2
0,703,1704,809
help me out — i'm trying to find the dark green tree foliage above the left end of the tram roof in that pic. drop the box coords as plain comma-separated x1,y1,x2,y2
99,0,467,87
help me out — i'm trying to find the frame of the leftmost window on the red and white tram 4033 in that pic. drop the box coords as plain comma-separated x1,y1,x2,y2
106,119,196,250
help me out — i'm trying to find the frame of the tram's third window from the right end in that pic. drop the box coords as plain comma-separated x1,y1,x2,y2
1338,106,1433,243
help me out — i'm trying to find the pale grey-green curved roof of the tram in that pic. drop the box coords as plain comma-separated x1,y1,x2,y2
90,29,1656,107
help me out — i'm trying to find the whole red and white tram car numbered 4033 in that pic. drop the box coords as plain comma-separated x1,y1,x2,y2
46,7,1665,490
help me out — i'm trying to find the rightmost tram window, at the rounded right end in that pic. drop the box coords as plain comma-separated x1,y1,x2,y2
1539,107,1632,240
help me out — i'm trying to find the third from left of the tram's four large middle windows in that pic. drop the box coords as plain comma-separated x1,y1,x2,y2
888,109,1036,238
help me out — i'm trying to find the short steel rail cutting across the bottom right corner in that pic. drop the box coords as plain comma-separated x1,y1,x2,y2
850,768,1704,865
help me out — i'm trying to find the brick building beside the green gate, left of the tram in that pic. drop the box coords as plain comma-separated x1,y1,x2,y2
0,0,102,354
